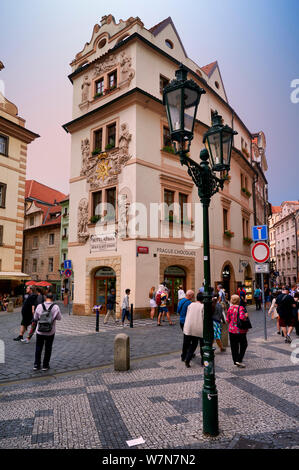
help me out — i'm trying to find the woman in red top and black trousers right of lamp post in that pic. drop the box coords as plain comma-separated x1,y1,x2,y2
226,294,248,368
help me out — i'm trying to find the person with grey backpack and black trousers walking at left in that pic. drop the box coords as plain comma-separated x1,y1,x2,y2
33,292,62,371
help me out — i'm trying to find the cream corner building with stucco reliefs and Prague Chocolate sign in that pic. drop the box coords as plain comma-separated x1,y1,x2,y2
63,15,267,316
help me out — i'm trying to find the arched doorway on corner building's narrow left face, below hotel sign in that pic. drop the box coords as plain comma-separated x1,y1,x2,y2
94,266,116,315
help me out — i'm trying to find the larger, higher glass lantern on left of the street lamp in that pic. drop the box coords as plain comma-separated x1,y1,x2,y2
163,64,205,144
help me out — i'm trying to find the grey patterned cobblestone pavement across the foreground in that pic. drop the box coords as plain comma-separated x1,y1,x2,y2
0,304,299,449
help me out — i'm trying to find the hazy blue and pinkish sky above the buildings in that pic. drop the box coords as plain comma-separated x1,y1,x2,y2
0,0,299,205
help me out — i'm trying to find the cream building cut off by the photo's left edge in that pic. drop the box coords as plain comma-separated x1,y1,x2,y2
0,63,39,297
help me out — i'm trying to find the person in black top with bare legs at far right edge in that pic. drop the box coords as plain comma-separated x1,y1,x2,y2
275,286,296,343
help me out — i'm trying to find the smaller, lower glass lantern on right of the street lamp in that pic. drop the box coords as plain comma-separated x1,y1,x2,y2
203,113,237,171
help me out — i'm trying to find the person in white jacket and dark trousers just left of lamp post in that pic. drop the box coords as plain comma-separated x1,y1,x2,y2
181,292,204,368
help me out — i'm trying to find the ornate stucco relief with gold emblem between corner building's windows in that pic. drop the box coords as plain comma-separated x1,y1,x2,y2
80,123,132,190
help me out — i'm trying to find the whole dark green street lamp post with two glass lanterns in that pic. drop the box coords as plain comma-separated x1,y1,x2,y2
163,64,237,436
